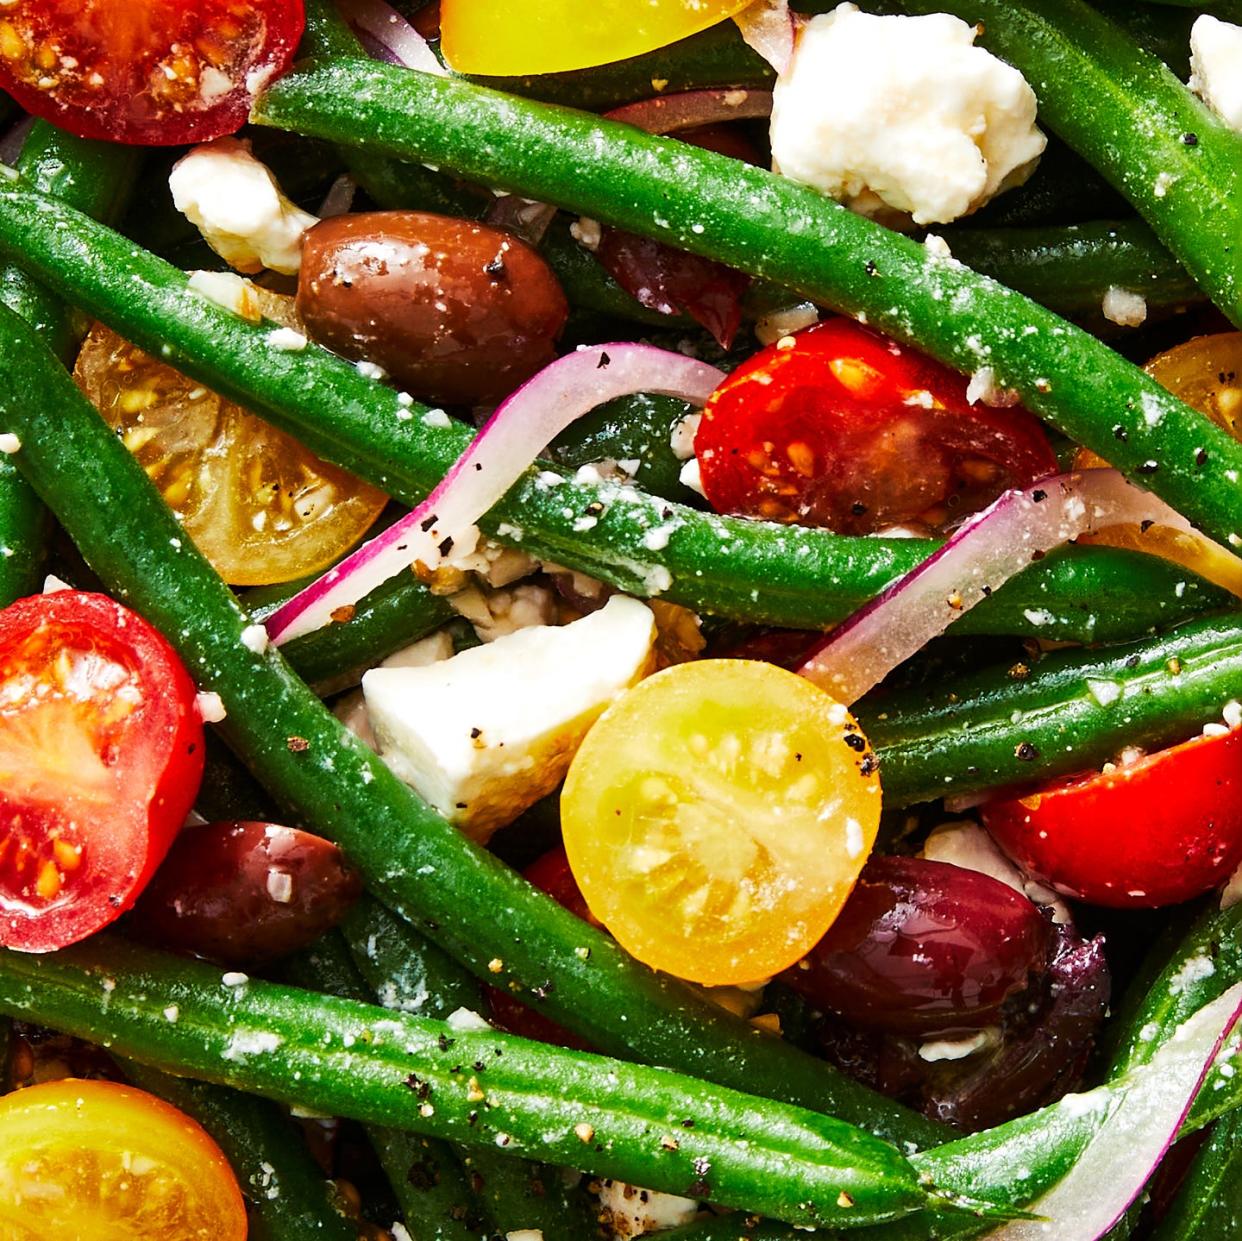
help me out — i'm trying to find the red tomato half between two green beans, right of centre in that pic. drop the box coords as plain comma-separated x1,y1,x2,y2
694,318,1057,534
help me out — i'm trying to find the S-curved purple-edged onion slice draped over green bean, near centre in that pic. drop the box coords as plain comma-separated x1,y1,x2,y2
267,343,724,643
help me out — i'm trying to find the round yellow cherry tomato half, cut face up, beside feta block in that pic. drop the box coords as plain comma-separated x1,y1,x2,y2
560,660,881,985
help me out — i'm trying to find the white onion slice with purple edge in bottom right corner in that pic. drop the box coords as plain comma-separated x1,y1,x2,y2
989,983,1242,1241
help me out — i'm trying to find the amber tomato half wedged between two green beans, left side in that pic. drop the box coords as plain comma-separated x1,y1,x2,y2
73,315,385,586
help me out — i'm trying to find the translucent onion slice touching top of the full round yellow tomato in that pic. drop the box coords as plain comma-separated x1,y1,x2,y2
797,470,1231,703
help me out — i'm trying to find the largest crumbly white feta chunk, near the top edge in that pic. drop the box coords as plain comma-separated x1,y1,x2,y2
771,4,1047,224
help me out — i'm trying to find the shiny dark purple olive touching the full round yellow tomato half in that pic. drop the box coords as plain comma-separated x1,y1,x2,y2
784,857,1052,1034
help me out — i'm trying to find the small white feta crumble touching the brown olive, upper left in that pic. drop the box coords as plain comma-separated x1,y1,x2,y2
168,138,319,276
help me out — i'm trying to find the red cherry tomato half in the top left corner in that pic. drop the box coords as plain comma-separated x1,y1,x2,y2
0,0,306,145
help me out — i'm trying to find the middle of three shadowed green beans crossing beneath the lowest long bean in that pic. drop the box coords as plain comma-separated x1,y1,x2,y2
284,932,494,1241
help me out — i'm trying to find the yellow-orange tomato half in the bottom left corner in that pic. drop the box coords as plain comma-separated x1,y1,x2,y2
0,1078,247,1241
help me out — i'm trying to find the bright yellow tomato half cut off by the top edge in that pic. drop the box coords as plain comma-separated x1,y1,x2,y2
440,0,754,76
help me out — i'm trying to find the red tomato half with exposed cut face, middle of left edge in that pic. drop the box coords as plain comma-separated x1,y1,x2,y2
0,590,202,952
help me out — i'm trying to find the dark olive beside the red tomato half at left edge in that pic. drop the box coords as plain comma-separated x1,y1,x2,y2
129,822,361,965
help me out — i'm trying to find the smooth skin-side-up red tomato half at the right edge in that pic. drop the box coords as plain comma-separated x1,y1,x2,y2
981,729,1242,909
